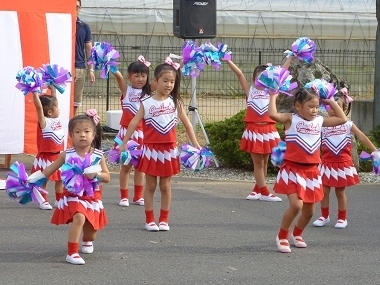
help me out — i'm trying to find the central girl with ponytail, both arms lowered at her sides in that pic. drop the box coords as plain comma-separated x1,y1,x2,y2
120,57,200,231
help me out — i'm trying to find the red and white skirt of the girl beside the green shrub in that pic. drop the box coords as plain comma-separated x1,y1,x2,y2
240,123,280,154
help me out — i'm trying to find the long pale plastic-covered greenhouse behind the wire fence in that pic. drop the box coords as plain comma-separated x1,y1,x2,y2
80,0,377,121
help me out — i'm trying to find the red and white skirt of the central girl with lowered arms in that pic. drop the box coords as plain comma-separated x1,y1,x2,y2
137,143,180,177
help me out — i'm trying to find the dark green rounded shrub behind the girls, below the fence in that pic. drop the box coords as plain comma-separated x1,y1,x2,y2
205,110,283,173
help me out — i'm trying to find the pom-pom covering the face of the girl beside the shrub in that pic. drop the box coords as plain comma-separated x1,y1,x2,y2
255,66,298,96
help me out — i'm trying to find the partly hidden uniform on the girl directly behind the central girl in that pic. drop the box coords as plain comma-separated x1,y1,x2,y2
117,86,144,145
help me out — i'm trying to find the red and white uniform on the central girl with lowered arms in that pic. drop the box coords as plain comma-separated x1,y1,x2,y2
137,96,180,177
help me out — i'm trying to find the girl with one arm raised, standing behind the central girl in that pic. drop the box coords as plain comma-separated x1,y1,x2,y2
110,55,150,207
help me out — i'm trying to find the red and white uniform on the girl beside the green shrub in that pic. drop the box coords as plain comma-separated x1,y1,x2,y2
240,85,280,154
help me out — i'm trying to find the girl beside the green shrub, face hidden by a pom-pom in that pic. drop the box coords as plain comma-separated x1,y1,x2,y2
226,57,293,202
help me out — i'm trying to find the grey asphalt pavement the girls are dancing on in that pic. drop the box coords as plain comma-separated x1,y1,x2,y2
0,156,380,285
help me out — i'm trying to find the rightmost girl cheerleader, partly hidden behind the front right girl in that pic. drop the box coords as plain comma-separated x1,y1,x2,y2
313,88,377,229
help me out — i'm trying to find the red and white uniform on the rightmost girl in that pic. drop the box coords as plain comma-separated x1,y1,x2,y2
319,121,360,187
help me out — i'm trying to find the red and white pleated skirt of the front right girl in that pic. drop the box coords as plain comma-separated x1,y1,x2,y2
273,160,323,203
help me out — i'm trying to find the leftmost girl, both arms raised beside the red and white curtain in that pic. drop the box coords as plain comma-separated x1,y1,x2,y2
31,86,65,210
